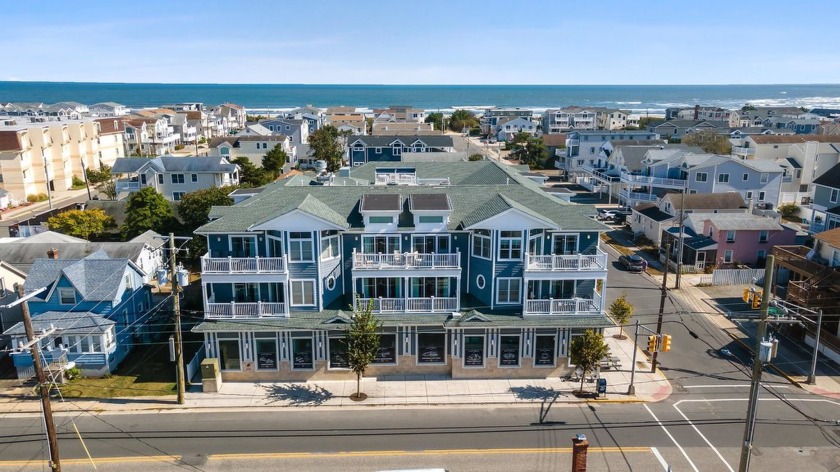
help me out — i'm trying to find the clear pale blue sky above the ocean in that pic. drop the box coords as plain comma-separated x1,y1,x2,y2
6,0,840,84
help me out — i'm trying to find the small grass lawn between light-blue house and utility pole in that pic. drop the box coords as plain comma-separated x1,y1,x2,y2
61,344,175,398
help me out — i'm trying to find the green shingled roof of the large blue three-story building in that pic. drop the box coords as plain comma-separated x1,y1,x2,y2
196,161,606,233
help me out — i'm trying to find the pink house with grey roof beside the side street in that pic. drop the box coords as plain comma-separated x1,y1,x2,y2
660,213,796,272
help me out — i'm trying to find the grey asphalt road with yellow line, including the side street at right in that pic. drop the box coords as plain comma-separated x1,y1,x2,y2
0,236,840,471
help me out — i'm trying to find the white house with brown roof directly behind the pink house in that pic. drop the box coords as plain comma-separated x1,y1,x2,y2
627,192,750,246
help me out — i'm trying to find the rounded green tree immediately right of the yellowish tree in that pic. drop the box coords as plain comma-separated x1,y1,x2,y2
120,187,177,240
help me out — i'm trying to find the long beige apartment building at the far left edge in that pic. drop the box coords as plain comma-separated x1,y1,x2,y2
0,118,125,203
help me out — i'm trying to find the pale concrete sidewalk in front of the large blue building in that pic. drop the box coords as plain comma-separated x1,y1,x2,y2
0,328,671,415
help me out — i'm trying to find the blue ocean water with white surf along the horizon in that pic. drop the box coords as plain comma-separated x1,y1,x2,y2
0,82,840,113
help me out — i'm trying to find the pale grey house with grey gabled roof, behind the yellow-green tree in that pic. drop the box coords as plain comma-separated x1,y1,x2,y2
111,156,239,202
